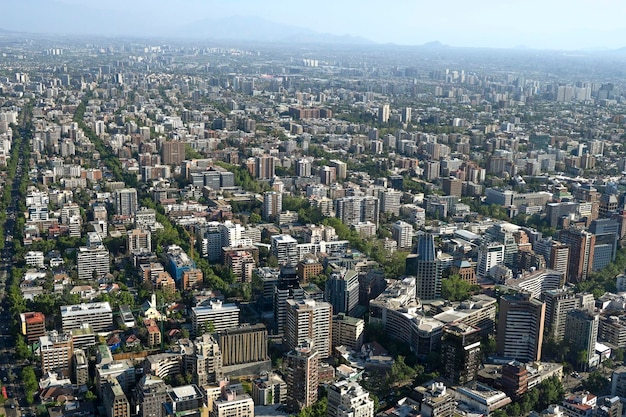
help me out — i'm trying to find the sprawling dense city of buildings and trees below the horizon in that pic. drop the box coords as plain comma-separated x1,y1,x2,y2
0,29,626,417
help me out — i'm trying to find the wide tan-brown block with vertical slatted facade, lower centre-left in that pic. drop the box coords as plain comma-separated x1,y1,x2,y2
216,324,268,366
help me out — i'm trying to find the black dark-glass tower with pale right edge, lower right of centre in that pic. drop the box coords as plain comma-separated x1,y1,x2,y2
441,322,481,385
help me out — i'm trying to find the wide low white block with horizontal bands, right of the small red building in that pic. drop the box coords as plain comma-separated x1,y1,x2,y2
61,301,113,333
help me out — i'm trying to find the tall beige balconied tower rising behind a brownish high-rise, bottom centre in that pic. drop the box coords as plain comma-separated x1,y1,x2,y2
285,299,332,358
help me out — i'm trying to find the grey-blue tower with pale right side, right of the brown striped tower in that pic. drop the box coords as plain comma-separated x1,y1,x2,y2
564,310,600,369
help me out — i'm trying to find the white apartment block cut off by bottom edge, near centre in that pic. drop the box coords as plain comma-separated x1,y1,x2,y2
326,380,374,417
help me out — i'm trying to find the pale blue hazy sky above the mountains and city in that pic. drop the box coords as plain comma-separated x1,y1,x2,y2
0,0,626,49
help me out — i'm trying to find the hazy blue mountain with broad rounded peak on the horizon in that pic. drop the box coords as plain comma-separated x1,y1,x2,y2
167,16,373,44
